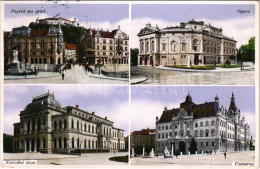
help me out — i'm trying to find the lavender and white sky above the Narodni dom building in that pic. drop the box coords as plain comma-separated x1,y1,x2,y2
4,85,129,136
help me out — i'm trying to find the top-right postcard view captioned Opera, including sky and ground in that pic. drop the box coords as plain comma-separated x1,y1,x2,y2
130,3,257,85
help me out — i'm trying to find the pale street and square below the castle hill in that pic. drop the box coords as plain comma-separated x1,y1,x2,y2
4,65,128,85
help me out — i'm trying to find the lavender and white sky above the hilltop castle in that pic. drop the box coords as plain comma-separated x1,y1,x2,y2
4,1,129,33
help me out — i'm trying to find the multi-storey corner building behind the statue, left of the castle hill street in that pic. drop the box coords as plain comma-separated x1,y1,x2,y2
4,25,64,68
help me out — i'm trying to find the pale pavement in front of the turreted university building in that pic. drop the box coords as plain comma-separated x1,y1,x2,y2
130,151,255,166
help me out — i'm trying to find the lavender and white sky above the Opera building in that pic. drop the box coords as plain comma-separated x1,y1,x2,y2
130,4,255,48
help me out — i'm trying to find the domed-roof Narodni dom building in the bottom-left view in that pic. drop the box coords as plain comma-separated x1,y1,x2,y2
13,92,125,153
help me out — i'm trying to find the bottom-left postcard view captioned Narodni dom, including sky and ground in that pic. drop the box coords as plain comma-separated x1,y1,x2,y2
3,85,129,166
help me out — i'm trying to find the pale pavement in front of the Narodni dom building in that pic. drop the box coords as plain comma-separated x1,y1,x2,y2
3,153,128,165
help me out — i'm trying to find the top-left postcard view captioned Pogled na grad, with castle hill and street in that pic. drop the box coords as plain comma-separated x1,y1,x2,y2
2,1,129,85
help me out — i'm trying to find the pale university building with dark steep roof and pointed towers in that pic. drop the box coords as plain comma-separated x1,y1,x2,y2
155,93,250,154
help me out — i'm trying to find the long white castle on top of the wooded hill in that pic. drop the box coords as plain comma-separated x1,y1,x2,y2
36,17,78,26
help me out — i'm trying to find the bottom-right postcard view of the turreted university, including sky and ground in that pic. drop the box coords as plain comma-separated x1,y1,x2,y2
130,86,256,166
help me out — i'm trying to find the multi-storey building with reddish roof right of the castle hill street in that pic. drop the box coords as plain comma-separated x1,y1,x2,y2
78,26,129,65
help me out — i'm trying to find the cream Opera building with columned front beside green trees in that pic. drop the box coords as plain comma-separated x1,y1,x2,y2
137,20,237,66
